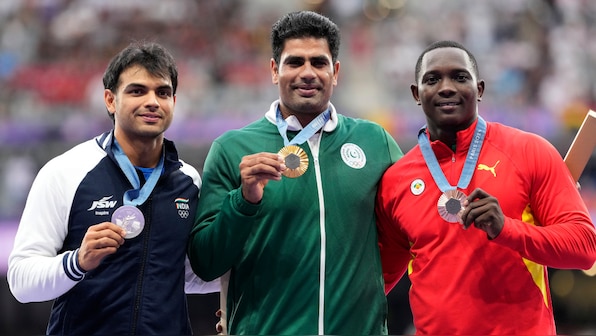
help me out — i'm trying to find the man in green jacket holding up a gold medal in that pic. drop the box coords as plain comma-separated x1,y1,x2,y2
189,11,402,335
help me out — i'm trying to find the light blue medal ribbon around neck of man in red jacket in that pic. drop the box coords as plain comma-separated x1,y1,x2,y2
418,116,486,192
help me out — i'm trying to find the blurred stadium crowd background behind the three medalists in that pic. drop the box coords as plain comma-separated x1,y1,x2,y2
0,0,596,335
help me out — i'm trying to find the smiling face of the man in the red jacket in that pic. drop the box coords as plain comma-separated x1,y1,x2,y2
411,47,484,142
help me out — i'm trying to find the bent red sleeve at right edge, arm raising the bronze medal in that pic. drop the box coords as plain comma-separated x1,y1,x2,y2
494,135,596,269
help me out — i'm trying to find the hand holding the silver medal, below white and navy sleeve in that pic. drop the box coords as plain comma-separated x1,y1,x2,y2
78,222,126,271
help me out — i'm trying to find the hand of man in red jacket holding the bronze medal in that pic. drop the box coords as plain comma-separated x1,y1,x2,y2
461,188,505,239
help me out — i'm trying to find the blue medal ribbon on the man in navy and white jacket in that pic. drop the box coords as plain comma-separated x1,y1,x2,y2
113,138,164,205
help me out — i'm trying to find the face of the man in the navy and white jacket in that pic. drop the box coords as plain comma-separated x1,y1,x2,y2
104,65,176,144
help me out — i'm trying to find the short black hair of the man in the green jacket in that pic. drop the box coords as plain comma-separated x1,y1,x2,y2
271,11,340,64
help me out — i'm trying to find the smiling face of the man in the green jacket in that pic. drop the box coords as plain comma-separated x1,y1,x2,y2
271,37,339,126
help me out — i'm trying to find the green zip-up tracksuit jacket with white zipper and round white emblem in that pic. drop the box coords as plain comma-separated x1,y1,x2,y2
189,102,403,335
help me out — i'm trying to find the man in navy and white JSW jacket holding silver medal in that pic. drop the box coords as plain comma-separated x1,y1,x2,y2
8,44,219,335
